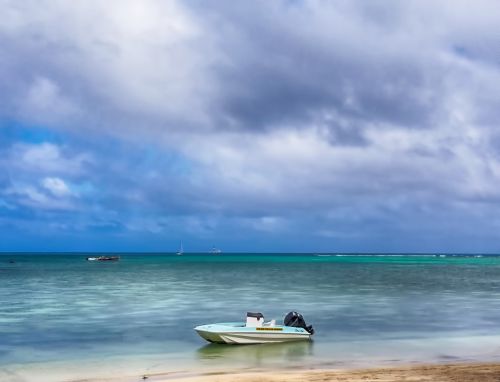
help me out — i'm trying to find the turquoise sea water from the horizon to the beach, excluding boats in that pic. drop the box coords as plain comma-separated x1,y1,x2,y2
0,254,500,374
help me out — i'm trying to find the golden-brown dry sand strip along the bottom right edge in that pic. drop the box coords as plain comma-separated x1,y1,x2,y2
134,363,500,382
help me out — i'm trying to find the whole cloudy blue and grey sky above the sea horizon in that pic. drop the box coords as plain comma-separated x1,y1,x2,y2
0,0,500,253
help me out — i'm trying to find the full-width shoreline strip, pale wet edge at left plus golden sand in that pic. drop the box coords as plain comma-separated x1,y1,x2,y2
5,357,500,382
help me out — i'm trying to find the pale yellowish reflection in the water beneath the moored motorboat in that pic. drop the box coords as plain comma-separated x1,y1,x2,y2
197,341,313,366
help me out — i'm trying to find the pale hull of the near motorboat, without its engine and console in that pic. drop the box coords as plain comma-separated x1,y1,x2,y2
194,323,311,344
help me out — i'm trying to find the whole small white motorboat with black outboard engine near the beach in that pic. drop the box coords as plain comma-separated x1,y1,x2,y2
194,312,314,344
